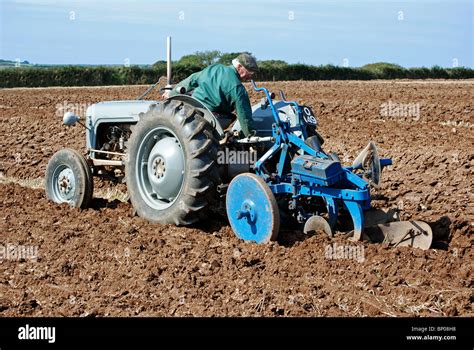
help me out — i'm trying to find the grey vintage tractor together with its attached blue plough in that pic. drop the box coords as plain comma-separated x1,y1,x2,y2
46,38,432,249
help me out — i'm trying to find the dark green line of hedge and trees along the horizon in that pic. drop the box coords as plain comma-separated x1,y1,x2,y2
0,51,474,88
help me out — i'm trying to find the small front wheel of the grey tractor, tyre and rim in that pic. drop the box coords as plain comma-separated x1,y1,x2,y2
45,148,93,208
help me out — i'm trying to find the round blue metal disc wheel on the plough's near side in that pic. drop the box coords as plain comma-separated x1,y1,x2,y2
226,173,280,243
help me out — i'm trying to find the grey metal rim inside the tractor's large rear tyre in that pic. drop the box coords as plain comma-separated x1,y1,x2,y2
136,126,185,210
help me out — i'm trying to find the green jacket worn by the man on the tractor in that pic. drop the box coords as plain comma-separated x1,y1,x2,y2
170,63,254,136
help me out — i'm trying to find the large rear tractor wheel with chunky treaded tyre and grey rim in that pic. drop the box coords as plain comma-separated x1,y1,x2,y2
125,100,219,225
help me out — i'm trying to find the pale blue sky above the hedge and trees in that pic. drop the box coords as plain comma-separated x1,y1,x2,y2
0,0,474,67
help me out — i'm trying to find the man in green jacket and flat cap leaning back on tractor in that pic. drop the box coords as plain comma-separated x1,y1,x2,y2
163,53,258,136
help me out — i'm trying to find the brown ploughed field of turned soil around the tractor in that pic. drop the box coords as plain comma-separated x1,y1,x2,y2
0,80,474,316
